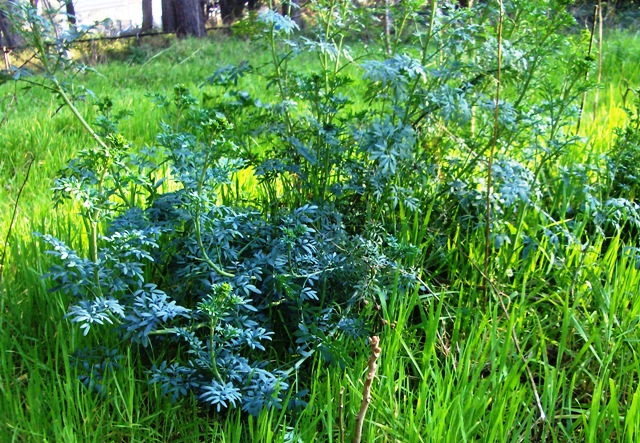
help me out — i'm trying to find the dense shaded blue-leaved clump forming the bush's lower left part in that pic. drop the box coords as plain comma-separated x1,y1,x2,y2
42,82,396,414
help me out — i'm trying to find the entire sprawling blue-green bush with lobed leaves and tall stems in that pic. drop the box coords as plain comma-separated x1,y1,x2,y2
37,0,640,414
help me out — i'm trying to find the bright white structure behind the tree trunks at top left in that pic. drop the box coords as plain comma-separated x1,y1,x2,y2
73,0,162,32
